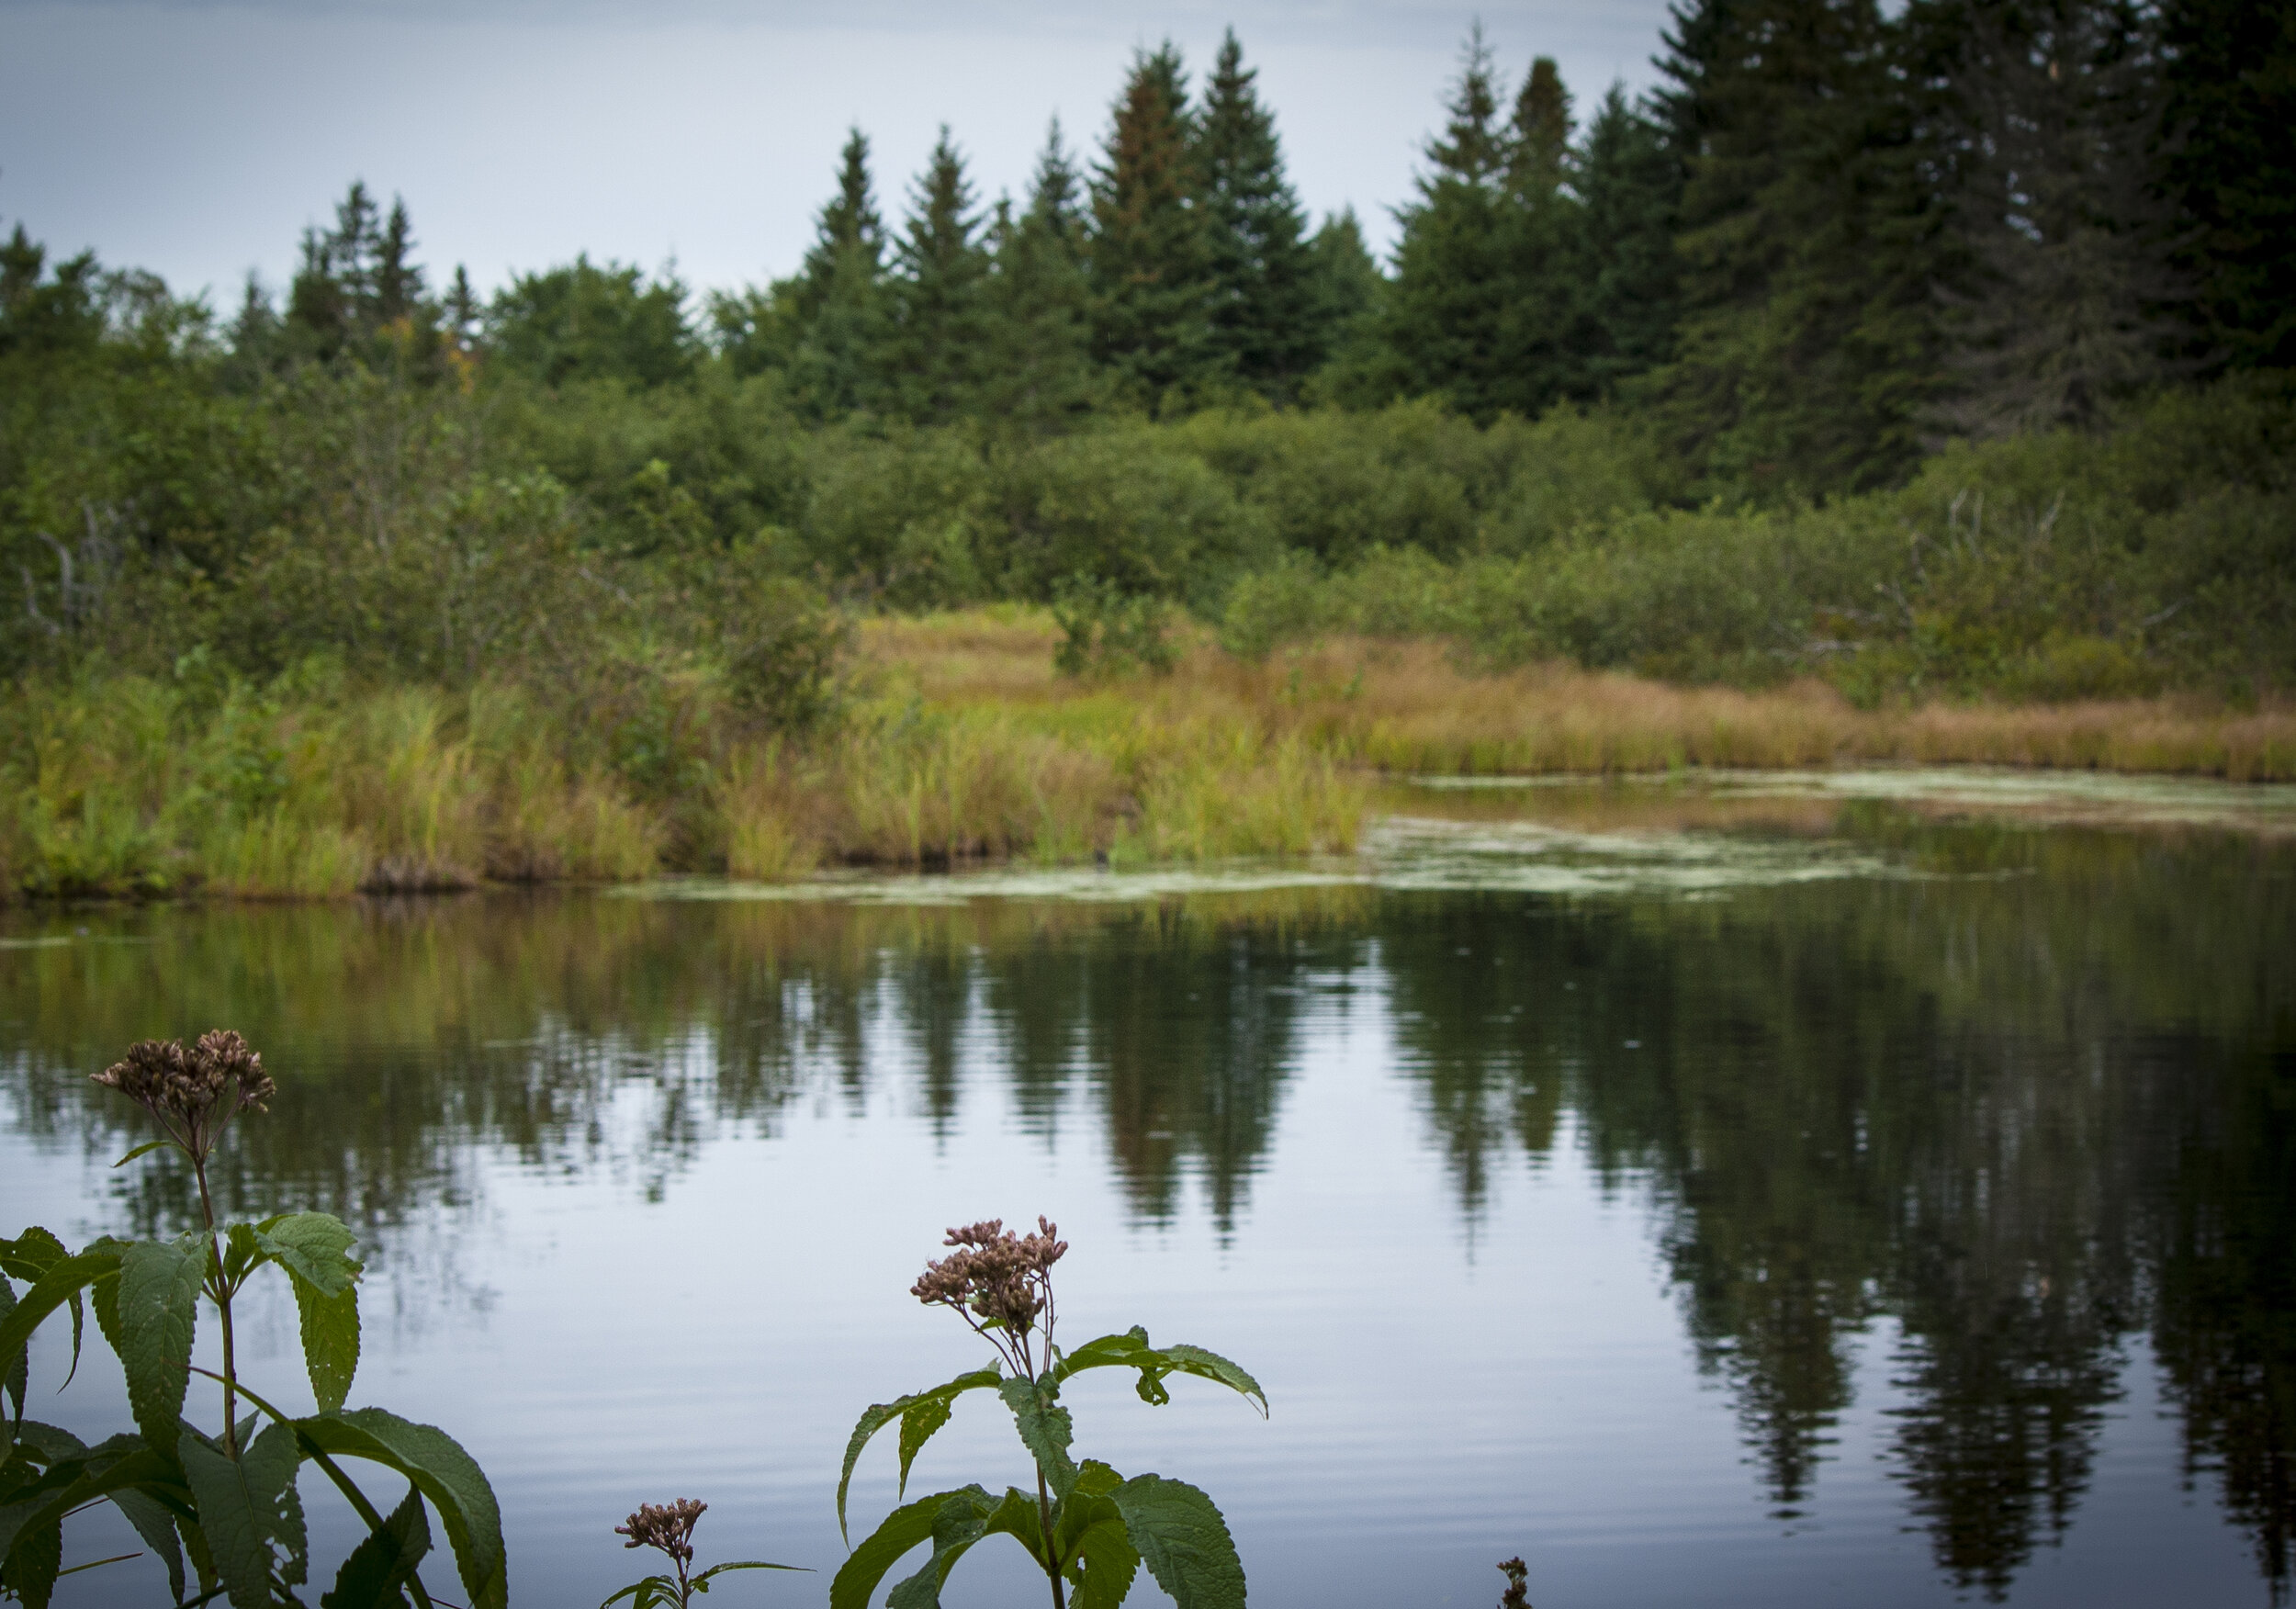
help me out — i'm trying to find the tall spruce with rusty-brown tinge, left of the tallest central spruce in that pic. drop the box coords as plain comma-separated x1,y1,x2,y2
1088,41,1217,406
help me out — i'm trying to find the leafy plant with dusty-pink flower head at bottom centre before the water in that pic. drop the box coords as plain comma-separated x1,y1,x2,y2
829,1219,1267,1609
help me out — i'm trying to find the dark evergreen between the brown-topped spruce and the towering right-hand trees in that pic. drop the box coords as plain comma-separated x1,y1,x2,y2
1575,84,1683,395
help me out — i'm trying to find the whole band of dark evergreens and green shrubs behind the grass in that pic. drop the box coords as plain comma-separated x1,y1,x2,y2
0,0,2296,726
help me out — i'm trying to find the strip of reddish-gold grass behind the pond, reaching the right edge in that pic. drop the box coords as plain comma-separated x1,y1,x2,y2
863,611,2296,782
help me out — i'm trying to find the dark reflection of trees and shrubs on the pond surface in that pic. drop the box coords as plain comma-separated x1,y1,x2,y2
0,804,2296,1598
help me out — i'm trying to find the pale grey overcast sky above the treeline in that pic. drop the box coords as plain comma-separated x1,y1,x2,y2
0,0,1665,309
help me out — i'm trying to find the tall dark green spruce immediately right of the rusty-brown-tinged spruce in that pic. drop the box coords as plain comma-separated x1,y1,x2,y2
1197,28,1330,401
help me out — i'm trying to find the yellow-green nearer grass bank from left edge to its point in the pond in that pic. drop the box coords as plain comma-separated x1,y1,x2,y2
0,656,1368,897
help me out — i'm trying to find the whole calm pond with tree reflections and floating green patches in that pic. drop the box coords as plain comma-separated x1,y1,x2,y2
0,771,2296,1609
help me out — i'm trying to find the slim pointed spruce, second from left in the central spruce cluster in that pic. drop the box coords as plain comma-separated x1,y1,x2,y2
884,124,987,422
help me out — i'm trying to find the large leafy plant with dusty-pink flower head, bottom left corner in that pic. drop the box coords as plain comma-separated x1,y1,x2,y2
0,1030,508,1609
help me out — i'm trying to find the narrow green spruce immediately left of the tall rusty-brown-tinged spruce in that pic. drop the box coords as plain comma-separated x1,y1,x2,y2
981,117,1100,432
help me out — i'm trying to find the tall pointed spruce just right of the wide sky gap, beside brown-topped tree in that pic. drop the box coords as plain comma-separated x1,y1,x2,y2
1382,23,1514,418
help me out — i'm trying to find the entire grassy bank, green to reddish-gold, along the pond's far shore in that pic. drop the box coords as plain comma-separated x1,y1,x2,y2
0,608,2296,897
